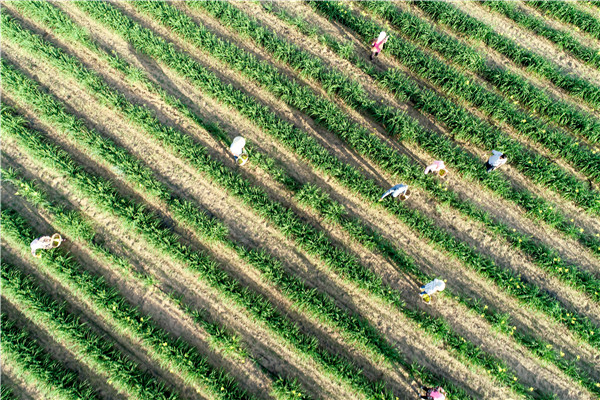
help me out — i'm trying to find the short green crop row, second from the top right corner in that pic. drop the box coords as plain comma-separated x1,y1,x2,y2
481,0,600,69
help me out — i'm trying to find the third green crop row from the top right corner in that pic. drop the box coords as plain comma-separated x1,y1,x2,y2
412,1,600,107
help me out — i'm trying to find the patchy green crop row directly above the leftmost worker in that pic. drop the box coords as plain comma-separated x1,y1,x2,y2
1,167,316,400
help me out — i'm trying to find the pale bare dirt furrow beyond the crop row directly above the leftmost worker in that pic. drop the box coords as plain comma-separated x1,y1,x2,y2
1,131,349,399
